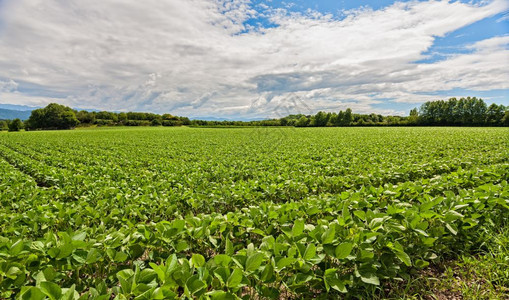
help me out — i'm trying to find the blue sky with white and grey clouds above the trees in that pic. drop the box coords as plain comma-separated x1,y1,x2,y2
0,0,509,120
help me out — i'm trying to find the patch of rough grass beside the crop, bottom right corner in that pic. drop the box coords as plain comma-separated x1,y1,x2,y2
376,226,509,300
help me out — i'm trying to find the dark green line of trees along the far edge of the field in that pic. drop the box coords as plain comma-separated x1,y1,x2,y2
0,97,509,131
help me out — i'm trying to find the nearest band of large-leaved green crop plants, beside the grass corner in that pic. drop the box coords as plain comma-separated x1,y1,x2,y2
0,164,509,299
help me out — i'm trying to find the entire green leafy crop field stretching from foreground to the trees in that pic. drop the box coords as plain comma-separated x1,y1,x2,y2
0,127,509,299
